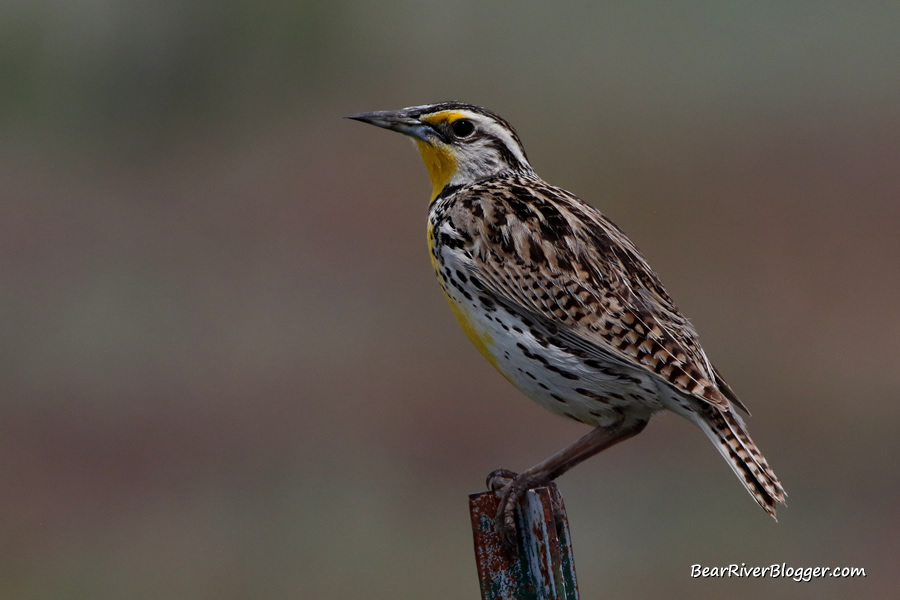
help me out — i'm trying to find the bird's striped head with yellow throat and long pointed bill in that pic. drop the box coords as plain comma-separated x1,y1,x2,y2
347,102,532,200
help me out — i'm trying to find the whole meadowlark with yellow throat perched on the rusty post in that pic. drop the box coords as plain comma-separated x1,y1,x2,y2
349,102,785,539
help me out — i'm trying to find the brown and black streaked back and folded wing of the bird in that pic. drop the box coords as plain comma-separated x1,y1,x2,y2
448,177,743,410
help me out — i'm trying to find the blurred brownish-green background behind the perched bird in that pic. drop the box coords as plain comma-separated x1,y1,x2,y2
0,0,900,599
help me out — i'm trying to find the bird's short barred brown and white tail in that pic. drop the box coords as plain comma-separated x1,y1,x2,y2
695,404,787,520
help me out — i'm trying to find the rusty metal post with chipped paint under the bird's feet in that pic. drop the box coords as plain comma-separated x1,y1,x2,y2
469,483,578,600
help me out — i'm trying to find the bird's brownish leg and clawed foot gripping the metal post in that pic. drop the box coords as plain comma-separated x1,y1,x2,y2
487,416,648,548
